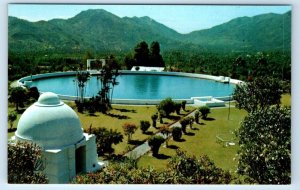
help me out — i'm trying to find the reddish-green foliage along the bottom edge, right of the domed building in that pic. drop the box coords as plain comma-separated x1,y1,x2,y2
73,151,233,184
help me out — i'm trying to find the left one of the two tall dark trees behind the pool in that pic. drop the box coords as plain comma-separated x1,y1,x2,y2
133,41,149,66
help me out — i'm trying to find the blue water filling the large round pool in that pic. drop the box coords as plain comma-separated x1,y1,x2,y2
32,74,235,99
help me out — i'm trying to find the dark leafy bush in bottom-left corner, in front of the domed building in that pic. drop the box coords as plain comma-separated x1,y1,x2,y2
7,142,48,184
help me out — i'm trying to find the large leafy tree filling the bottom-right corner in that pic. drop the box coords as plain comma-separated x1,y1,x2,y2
237,106,291,184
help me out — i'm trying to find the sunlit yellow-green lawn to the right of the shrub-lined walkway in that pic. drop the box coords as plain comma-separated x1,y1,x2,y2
138,108,246,171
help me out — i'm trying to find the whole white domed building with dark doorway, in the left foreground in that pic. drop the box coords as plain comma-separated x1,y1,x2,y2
14,92,103,183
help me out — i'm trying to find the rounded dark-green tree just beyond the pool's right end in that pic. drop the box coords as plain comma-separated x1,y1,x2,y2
233,77,282,113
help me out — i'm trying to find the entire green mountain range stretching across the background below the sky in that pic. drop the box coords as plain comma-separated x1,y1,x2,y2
8,9,291,53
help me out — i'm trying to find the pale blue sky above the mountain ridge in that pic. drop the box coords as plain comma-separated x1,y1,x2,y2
8,4,291,33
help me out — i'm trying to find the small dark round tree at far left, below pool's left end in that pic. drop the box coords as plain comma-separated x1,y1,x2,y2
9,87,27,111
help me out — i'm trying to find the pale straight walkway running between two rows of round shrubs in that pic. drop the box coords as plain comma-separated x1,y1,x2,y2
124,109,197,159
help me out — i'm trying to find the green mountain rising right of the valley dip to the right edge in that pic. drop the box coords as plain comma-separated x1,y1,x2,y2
185,11,291,51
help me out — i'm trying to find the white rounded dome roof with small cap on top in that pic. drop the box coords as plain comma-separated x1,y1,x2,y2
15,92,84,149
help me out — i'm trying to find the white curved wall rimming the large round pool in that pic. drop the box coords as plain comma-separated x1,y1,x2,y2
17,70,243,105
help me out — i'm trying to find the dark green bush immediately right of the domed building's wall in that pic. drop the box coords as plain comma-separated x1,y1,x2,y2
85,126,123,155
